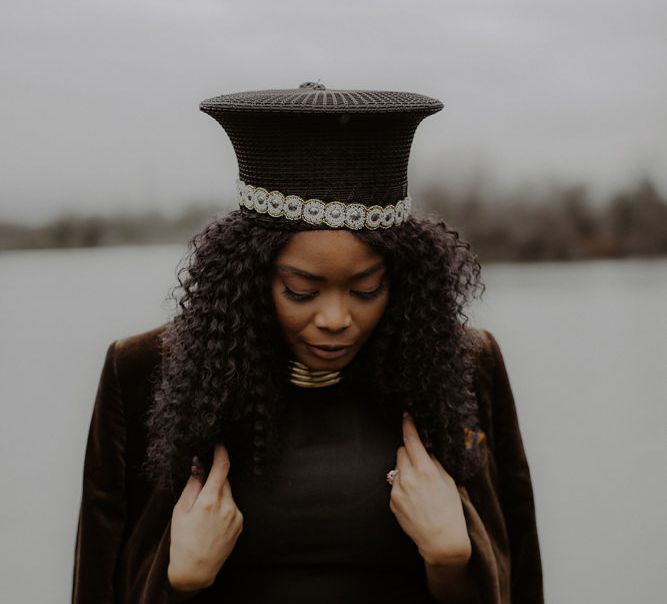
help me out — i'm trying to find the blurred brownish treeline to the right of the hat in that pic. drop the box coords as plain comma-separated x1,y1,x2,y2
420,180,667,261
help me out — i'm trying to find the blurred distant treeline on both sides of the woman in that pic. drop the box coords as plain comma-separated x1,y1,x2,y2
0,180,667,261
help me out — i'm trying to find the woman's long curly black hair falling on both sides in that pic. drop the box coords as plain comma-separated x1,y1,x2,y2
142,210,484,492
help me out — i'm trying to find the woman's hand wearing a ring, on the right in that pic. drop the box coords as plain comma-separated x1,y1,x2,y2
389,415,472,566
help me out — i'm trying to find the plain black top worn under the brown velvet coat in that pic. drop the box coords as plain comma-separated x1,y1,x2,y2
211,379,435,604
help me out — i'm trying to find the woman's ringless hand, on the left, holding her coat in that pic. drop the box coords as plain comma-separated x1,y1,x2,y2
167,444,243,591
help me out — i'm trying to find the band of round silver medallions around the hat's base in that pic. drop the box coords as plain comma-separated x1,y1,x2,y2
236,180,412,230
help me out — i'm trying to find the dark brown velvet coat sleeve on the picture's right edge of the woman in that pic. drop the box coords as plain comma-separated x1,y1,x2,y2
484,330,544,604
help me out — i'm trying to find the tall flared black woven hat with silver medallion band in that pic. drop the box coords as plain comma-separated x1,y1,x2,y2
200,82,443,230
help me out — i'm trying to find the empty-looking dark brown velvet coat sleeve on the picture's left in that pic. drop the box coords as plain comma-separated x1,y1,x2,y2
72,341,126,604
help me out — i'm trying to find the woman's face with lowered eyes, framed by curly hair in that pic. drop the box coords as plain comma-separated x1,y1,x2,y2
272,230,389,371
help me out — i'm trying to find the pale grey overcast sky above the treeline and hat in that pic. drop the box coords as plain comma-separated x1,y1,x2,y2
0,0,667,223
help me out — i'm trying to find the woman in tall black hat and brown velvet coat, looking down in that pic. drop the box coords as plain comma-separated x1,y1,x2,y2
73,83,542,604
